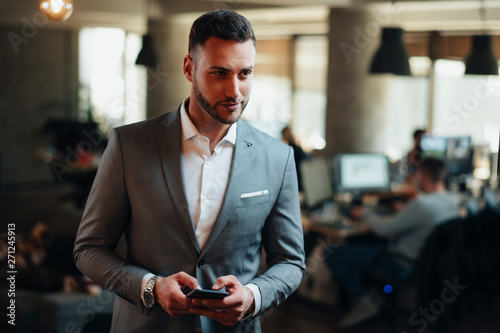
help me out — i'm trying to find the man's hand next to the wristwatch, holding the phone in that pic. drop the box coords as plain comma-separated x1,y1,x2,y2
154,272,199,318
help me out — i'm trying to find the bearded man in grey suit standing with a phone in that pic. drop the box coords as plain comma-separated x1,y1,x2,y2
74,10,305,333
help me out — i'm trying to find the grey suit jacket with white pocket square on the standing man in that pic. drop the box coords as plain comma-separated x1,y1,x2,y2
74,110,305,333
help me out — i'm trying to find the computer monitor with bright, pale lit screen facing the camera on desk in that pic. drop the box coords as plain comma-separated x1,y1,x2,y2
334,154,391,193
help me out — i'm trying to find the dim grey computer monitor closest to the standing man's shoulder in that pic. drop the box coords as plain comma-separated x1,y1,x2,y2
300,157,333,209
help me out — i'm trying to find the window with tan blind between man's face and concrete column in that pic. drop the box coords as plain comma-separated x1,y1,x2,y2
243,36,328,150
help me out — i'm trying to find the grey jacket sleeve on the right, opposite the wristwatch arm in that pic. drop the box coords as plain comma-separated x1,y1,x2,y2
250,148,305,314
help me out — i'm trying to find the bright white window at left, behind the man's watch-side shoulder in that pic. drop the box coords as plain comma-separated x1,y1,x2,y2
79,28,146,132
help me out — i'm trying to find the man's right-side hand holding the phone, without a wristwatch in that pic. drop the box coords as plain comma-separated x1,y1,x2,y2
189,275,255,326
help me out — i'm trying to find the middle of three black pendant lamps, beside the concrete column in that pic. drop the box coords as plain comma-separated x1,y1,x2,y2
370,28,411,75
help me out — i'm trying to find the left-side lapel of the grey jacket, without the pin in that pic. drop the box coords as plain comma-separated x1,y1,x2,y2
155,109,200,253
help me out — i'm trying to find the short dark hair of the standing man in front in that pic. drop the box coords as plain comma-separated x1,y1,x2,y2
188,9,257,54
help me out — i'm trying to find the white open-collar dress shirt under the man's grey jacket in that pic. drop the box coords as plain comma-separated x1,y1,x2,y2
141,98,261,315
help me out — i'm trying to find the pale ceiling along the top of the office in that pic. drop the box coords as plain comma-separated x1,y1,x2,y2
0,0,500,35
